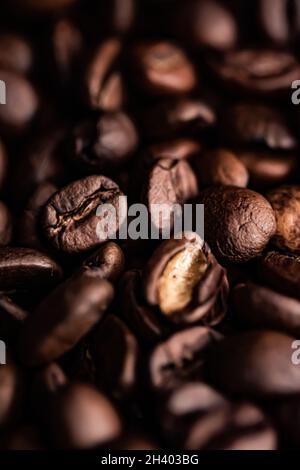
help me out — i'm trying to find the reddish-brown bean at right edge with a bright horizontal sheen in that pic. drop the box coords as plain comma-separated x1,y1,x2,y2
236,150,297,188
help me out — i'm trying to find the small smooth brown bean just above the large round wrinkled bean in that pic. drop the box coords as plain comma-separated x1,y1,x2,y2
197,149,249,188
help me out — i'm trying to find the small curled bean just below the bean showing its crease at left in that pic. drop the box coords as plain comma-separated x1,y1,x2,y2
81,242,125,282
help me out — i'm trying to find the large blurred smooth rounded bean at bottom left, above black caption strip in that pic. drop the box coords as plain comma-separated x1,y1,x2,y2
48,383,122,449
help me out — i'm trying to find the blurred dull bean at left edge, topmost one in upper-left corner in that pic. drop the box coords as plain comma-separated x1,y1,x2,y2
0,34,33,74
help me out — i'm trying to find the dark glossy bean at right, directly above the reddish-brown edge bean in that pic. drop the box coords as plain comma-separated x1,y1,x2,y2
221,103,297,150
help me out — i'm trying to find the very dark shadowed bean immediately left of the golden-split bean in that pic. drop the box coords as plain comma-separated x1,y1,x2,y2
120,270,169,345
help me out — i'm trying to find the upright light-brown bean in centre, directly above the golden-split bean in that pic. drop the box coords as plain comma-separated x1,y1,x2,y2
145,159,198,234
